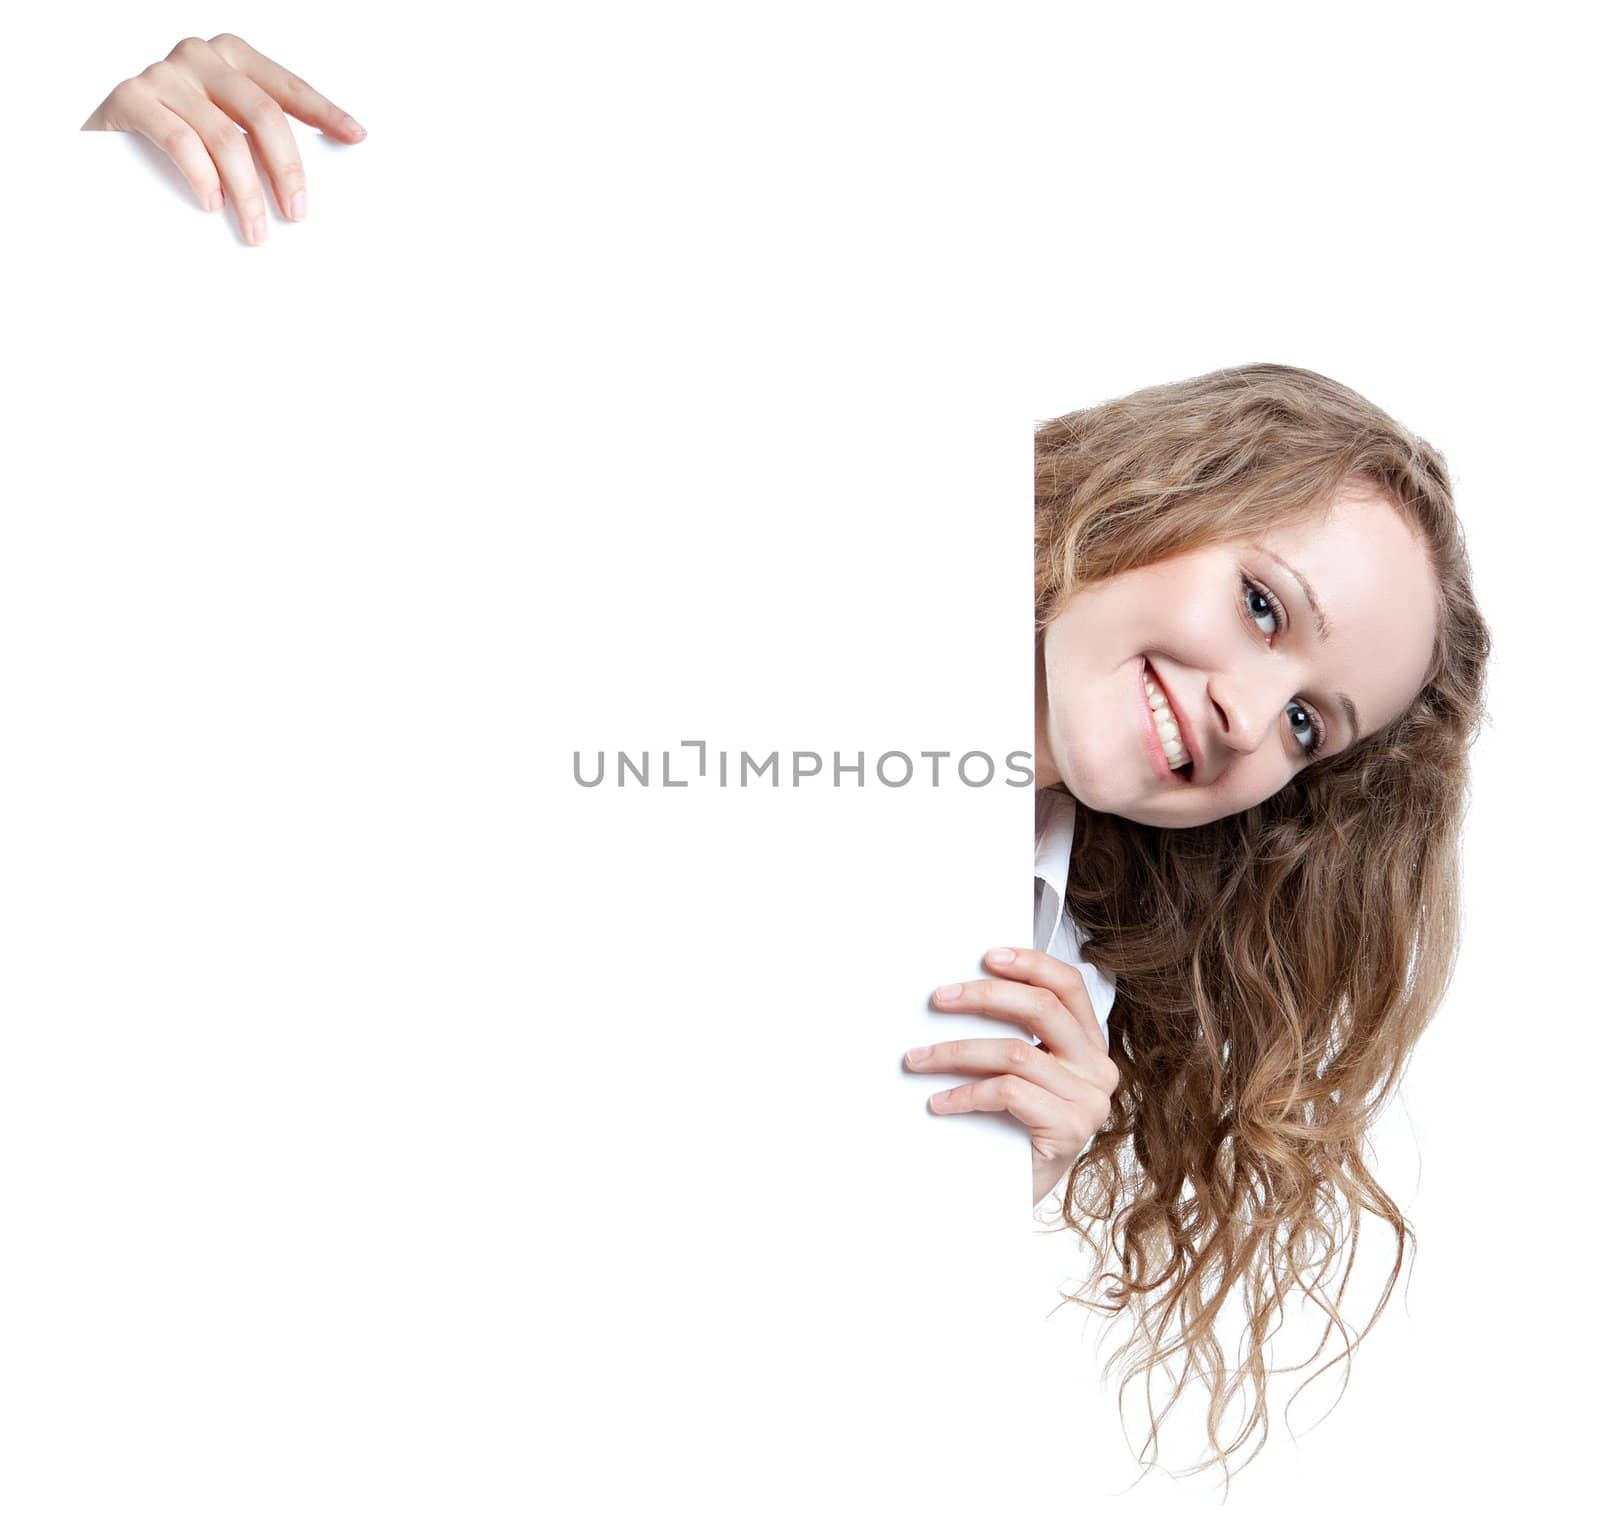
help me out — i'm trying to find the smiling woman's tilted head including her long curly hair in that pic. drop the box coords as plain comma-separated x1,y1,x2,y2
1034,365,1490,1473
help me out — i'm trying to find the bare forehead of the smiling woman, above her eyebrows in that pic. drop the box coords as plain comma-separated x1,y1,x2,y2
1256,485,1438,733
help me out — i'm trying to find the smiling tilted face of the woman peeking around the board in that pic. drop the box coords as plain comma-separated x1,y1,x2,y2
1034,485,1437,828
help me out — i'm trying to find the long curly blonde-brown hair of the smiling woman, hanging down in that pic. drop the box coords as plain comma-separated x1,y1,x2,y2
1034,365,1490,1492
